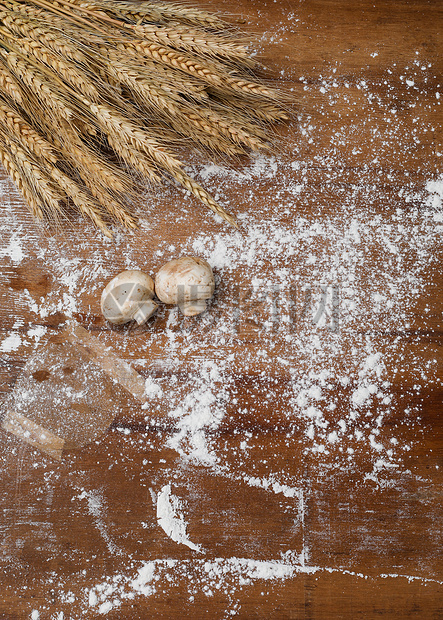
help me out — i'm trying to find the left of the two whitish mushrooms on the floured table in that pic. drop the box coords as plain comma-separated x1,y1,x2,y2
101,269,158,325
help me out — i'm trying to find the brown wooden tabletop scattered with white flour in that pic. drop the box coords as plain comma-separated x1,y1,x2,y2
0,0,443,620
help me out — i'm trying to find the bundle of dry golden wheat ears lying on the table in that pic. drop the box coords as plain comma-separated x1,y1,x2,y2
0,0,286,236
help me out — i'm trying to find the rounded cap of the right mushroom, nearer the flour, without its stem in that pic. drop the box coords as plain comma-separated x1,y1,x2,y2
155,256,215,304
